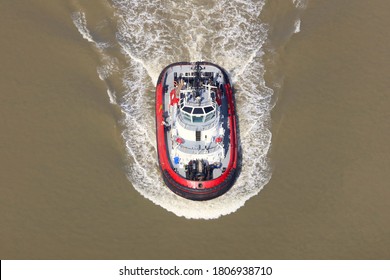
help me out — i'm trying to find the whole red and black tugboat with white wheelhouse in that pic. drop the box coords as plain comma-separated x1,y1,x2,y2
156,61,238,200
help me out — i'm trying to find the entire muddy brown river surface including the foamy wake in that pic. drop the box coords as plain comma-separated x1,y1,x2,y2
0,0,390,259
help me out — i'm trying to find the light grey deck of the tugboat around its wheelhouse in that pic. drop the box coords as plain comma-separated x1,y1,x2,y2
163,65,231,178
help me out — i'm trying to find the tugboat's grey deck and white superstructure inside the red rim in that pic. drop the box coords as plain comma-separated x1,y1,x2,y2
164,62,230,179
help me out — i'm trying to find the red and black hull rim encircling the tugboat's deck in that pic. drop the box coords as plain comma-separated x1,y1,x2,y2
156,62,238,200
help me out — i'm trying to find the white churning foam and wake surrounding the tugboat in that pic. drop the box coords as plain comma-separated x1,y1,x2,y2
72,0,305,219
